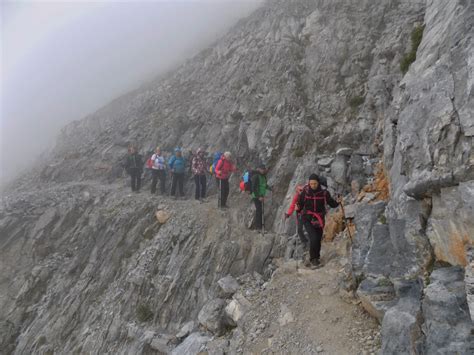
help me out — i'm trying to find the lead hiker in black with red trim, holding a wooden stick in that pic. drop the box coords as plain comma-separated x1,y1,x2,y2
296,174,339,268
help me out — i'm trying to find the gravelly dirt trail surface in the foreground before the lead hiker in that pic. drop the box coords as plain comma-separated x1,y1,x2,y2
208,236,380,355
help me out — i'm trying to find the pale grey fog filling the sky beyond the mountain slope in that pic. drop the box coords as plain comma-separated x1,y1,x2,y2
0,0,262,188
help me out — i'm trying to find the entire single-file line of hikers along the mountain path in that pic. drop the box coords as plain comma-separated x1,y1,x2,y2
124,147,342,268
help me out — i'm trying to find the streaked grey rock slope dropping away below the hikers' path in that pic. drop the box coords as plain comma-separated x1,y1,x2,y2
0,183,276,353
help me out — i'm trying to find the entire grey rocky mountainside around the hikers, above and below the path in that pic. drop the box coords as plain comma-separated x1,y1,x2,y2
0,0,474,353
